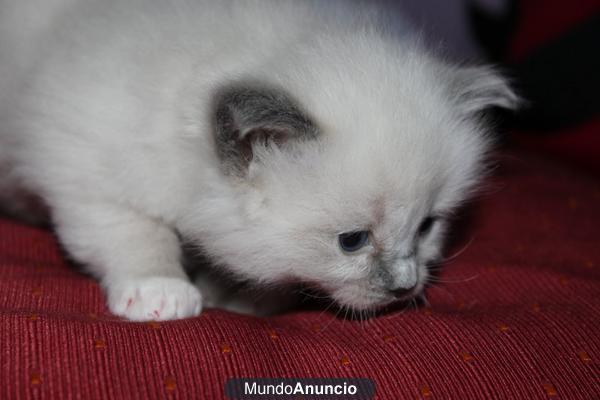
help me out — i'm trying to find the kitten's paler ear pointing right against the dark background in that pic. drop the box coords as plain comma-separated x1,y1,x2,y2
451,66,521,116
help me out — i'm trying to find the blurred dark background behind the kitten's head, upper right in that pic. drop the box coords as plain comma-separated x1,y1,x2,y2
375,0,600,175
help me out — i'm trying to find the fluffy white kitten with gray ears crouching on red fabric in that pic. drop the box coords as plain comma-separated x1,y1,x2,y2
0,0,517,320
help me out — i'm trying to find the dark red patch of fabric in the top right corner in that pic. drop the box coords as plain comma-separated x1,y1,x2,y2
508,0,600,61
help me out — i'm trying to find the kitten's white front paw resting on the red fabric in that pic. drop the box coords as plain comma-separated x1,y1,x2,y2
107,277,202,321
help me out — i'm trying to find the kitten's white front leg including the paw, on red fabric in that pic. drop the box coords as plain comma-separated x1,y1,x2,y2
53,202,202,321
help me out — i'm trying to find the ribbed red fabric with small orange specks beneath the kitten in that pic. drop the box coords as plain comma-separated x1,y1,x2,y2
0,149,600,399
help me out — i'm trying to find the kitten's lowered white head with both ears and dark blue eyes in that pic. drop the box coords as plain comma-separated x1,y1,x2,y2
206,56,516,310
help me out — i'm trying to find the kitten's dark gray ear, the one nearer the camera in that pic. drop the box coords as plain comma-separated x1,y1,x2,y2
215,86,317,176
